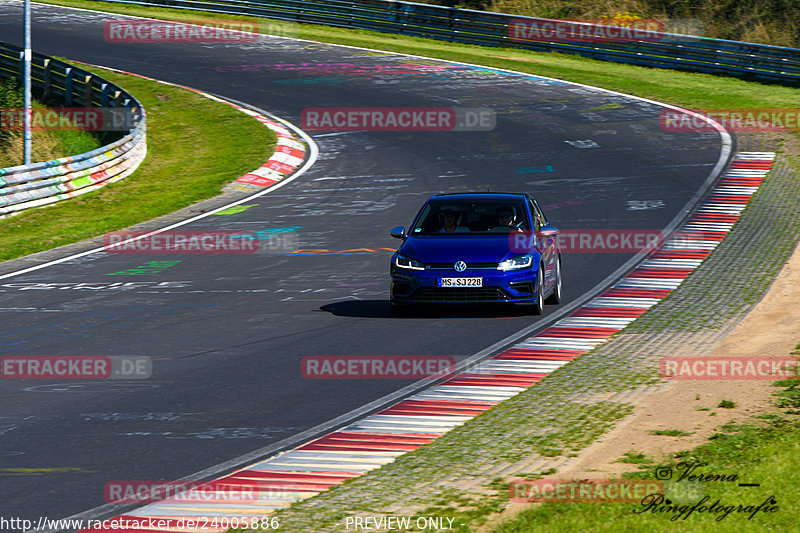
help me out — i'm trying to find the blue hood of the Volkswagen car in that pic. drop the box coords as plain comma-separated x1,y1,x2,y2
397,234,520,263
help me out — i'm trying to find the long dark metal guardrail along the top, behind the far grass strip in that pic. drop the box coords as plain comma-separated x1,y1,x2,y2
87,0,800,85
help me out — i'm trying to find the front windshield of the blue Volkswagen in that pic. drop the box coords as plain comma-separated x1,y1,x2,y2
410,198,530,235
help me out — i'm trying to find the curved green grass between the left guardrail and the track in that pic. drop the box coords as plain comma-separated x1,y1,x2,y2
0,65,275,261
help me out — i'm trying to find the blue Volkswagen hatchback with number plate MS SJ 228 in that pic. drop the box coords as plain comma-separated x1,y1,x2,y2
390,193,561,315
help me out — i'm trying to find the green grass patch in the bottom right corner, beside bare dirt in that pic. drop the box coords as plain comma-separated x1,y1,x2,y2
491,380,800,533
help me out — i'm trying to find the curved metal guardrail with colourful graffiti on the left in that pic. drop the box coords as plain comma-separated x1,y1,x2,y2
0,43,147,218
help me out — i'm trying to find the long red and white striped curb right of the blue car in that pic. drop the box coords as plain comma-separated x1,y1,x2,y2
76,152,775,533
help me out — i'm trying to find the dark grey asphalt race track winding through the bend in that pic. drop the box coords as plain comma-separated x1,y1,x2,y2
0,2,721,528
